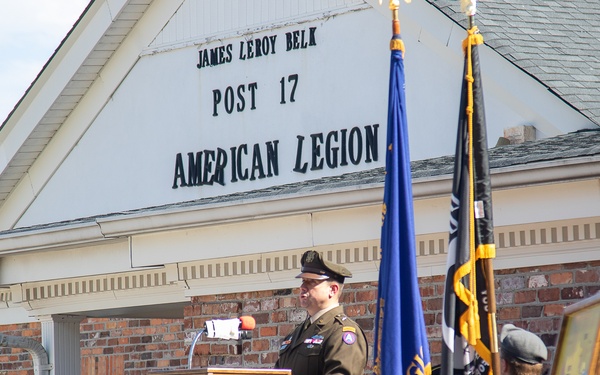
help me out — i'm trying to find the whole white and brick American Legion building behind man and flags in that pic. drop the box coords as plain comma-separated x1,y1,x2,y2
0,0,600,375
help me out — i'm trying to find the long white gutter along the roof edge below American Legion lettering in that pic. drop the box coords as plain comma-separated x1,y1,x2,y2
0,155,600,255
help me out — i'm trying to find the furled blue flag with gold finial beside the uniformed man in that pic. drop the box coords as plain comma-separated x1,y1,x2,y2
374,9,431,375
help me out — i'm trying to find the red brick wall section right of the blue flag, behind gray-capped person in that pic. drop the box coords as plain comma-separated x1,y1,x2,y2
420,261,600,374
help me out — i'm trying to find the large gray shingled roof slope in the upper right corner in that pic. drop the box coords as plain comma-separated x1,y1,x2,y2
427,0,600,125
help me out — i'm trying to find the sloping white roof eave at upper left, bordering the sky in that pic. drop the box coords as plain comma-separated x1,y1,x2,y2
0,0,152,210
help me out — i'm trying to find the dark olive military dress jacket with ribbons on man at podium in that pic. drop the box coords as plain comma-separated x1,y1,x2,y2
275,306,368,375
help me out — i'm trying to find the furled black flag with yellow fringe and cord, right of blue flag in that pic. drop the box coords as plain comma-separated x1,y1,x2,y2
442,27,499,375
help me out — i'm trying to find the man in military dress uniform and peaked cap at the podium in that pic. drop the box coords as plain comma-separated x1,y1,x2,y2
275,250,368,375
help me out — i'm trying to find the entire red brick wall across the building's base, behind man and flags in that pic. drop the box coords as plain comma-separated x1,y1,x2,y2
0,261,600,375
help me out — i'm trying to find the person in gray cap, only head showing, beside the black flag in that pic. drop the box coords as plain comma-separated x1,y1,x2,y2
500,324,548,375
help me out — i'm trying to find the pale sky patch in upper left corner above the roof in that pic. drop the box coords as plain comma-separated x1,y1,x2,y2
0,0,89,124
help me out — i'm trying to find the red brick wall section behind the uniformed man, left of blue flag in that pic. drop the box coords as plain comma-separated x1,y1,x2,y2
185,283,377,367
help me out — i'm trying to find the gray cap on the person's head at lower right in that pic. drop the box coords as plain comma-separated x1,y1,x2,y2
500,324,548,365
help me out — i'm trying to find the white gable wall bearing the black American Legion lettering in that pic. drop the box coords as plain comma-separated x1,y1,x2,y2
5,0,587,226
